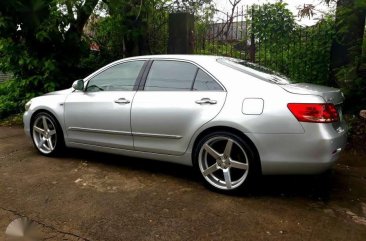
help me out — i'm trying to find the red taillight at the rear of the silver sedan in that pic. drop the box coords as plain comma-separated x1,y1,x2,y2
287,103,339,123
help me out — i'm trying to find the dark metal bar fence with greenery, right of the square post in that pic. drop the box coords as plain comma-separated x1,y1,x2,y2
195,7,333,84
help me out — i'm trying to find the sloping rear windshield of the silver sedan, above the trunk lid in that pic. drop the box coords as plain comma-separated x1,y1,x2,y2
217,57,292,85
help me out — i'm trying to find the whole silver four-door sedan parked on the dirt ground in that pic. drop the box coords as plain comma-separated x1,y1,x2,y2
24,55,346,192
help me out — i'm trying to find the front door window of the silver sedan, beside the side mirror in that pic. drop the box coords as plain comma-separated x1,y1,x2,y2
87,61,144,92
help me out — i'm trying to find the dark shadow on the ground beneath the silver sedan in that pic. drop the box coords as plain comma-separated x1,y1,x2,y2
61,149,336,202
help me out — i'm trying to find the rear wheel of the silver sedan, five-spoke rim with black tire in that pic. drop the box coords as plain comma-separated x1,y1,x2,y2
194,132,257,192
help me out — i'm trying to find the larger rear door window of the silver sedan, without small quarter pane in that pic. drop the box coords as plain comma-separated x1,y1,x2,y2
145,60,197,91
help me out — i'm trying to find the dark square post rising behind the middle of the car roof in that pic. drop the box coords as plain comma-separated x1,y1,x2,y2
168,13,194,54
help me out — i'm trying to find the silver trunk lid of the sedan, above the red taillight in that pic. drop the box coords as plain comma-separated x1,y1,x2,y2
280,83,344,104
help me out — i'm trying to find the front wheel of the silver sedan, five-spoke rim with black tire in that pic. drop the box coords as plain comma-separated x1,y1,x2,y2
31,112,65,156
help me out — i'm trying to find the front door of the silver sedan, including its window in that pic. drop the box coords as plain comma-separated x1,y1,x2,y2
65,61,144,149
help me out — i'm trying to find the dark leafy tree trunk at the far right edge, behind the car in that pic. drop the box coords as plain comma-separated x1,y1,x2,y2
330,0,366,112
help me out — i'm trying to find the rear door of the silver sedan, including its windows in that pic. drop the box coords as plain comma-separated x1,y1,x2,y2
131,60,226,155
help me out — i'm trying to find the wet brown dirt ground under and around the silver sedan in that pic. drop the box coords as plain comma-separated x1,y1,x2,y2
0,127,366,241
